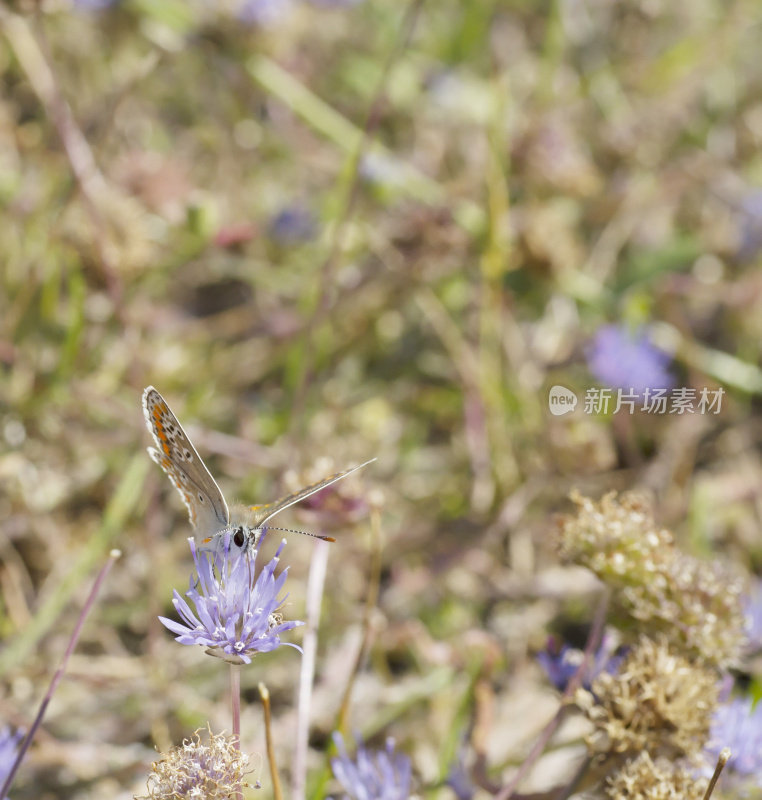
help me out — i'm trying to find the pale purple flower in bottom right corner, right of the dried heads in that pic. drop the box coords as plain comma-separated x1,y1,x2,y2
706,697,762,780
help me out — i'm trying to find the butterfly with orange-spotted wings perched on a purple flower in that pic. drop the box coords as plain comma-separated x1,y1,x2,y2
143,386,376,551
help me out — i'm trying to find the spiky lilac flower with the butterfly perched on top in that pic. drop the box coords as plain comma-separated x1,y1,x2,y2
159,533,304,664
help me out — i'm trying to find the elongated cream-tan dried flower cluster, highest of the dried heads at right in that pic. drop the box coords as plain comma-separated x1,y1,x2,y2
559,493,746,667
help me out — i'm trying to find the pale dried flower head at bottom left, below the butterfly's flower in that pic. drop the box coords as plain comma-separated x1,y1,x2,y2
135,729,259,800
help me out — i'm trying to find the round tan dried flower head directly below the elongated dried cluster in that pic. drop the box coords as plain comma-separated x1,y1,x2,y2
575,636,719,758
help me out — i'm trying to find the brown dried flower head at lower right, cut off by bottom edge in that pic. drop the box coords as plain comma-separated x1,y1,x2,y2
606,752,707,800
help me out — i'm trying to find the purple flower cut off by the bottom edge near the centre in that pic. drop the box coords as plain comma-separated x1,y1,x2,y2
331,733,412,800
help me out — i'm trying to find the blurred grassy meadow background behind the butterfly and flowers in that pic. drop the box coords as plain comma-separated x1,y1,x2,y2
0,0,762,800
